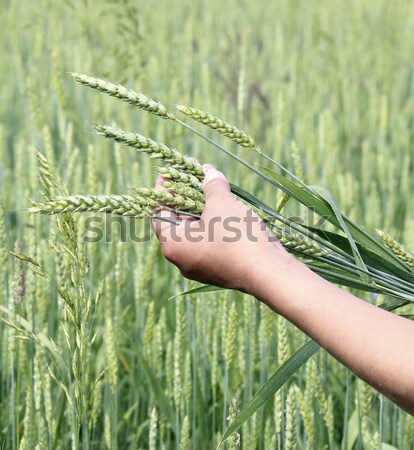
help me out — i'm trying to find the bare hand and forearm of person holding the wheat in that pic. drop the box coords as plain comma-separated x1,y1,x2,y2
153,164,414,415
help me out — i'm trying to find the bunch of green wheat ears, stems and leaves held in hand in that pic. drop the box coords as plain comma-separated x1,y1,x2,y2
30,73,414,302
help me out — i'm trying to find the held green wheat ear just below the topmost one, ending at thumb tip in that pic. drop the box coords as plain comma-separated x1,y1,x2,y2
94,124,204,179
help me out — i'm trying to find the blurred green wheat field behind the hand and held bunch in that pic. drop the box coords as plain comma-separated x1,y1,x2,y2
0,0,414,450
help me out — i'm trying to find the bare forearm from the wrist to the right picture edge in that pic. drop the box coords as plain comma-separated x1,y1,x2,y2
249,250,414,414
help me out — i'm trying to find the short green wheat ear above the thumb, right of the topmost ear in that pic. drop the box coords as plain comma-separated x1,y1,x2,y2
176,105,262,154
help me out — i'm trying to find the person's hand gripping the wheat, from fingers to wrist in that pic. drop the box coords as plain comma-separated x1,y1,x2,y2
152,164,292,295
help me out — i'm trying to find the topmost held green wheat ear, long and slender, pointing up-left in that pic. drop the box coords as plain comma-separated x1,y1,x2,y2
69,72,176,120
